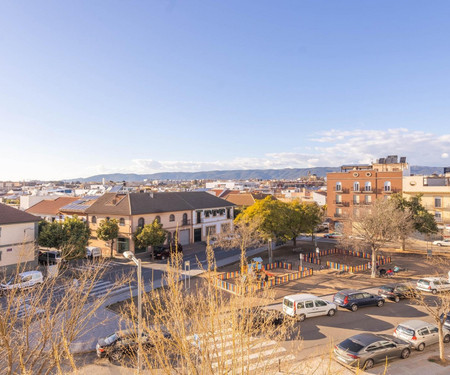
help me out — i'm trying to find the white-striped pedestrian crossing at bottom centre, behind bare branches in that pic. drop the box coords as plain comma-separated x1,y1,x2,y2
188,328,295,374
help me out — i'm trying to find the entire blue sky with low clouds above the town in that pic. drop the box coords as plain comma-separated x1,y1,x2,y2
0,0,450,180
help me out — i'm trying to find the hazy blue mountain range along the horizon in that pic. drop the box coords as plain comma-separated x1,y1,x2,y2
70,166,443,182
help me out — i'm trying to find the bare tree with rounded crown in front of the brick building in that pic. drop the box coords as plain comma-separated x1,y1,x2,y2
352,199,411,278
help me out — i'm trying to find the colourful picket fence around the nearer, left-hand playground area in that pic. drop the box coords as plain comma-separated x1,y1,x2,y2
216,262,313,295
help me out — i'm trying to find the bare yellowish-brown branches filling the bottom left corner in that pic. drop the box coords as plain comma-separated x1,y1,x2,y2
0,254,134,375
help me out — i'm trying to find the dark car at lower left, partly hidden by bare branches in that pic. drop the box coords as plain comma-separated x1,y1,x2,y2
96,330,171,361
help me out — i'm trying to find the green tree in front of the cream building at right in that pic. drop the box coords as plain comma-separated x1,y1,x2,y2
392,194,438,251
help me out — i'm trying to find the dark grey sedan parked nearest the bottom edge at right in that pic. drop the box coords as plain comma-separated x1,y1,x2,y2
334,333,411,369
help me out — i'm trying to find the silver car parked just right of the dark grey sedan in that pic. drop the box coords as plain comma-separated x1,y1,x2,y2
394,320,450,352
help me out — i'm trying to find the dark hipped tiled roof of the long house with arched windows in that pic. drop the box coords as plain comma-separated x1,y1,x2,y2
85,192,234,216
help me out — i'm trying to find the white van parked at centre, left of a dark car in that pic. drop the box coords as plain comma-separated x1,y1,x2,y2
283,294,337,322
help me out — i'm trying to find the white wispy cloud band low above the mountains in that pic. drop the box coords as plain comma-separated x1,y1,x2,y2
87,128,450,173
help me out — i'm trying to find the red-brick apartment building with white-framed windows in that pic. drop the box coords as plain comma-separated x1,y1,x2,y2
327,155,409,230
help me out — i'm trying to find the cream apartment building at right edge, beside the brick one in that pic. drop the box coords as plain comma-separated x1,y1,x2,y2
403,167,450,236
